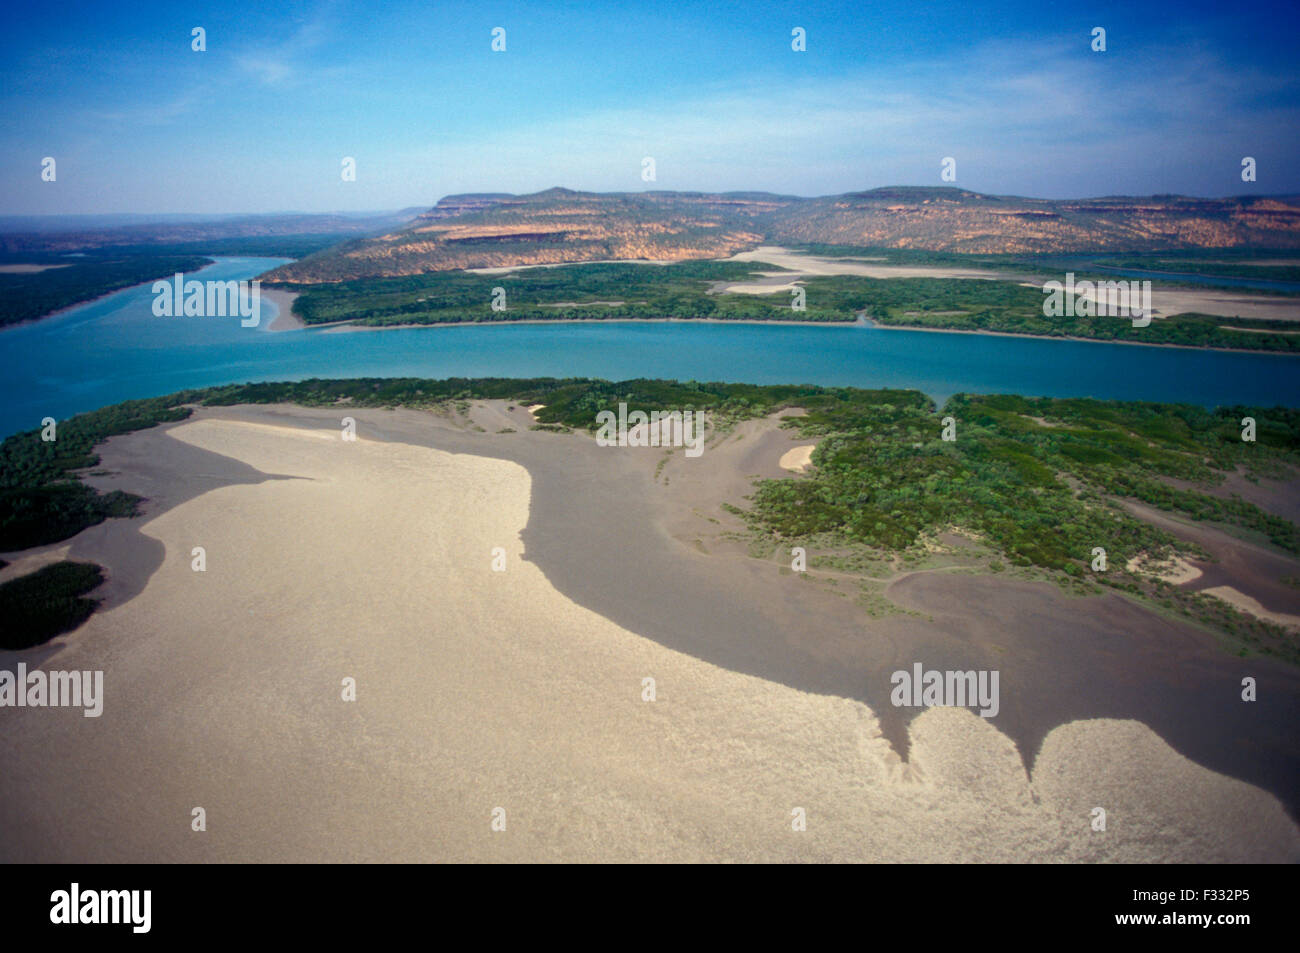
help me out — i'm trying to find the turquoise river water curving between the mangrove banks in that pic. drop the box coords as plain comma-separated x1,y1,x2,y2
0,257,1300,436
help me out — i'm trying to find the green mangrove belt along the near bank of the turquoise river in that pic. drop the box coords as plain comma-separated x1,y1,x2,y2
0,378,1300,660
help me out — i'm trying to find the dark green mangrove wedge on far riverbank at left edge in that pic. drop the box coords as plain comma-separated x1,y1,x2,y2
0,252,212,328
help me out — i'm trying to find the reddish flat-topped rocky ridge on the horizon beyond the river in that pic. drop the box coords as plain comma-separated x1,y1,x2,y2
267,187,1300,283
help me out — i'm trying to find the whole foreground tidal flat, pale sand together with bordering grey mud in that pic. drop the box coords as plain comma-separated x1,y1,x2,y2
0,402,1300,862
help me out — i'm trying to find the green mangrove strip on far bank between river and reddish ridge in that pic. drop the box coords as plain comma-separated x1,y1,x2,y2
279,256,1300,354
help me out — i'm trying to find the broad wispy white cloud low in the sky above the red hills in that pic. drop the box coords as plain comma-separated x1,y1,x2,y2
410,34,1300,200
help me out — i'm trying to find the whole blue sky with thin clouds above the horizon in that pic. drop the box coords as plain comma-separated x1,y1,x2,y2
0,0,1300,215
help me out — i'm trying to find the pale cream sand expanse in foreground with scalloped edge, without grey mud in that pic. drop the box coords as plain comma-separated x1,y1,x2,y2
0,411,1300,862
